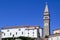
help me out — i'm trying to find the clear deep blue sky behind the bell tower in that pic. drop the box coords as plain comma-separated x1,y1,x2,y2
0,0,60,33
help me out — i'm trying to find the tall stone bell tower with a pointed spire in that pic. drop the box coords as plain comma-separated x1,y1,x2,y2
43,3,50,37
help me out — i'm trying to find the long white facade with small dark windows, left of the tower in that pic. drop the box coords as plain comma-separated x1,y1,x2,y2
1,27,42,38
